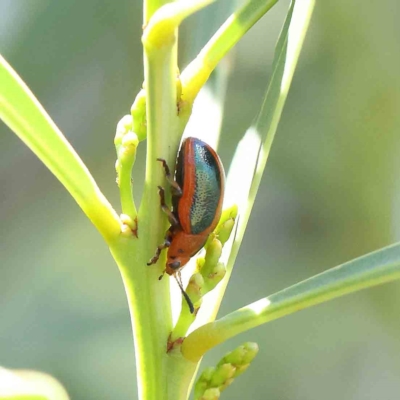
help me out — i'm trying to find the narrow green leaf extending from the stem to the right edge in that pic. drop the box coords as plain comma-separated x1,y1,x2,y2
182,244,400,362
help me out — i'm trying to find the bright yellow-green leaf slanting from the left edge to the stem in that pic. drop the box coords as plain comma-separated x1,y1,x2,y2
0,52,121,243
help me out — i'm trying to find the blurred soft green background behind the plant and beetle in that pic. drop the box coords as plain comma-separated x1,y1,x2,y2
0,0,400,400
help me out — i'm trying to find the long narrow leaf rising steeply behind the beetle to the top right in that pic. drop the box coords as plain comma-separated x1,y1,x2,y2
192,0,315,328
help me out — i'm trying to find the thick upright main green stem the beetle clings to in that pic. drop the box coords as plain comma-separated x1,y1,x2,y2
122,1,179,400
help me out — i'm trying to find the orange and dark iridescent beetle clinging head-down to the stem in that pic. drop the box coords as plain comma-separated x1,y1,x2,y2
147,137,225,313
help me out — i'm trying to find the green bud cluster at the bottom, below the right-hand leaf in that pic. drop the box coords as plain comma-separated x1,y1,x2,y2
194,342,258,400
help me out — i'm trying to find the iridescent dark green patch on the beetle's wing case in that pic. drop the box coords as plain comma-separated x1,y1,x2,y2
190,140,221,234
